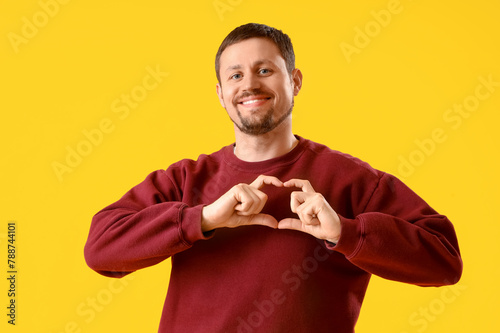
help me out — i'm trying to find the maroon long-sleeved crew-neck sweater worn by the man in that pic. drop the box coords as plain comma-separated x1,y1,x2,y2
85,137,462,333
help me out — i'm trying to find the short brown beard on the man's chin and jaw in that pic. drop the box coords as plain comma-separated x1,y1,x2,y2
233,99,294,135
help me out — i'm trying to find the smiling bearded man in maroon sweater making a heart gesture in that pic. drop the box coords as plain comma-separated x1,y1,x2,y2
85,24,462,333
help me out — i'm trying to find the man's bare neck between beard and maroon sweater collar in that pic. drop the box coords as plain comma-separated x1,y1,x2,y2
234,121,298,162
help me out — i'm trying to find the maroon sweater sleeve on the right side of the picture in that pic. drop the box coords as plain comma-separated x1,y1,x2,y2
327,174,462,286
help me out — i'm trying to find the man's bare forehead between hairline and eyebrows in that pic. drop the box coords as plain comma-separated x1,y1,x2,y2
220,38,286,71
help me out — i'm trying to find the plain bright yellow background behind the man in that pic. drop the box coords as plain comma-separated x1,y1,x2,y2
0,0,500,333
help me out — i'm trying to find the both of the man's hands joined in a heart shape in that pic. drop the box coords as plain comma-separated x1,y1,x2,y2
201,175,340,243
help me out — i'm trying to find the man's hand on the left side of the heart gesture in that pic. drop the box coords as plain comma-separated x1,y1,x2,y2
201,175,283,232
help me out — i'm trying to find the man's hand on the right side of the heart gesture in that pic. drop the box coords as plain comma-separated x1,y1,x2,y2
278,179,341,243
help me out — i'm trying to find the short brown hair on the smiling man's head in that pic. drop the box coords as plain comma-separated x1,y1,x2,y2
215,23,295,83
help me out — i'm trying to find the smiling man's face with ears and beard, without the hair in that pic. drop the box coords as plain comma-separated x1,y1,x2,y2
217,38,302,135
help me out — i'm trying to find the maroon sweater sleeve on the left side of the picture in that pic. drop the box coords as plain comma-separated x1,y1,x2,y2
84,170,211,277
